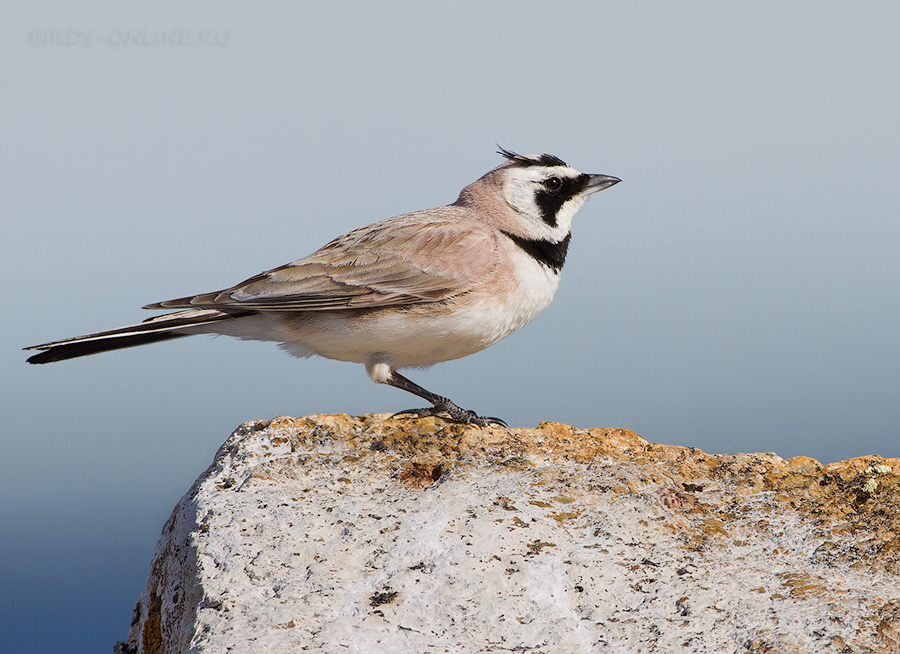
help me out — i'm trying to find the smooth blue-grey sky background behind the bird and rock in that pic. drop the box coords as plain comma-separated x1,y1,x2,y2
0,0,900,653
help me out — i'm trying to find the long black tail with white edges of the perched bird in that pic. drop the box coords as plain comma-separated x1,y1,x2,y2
25,309,253,363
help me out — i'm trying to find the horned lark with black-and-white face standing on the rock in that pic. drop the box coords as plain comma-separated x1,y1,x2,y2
25,146,621,427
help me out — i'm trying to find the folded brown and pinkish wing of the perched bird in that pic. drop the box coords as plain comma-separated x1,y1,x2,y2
145,212,497,311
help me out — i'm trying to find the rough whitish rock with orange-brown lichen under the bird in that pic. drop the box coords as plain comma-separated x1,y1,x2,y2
116,415,900,654
